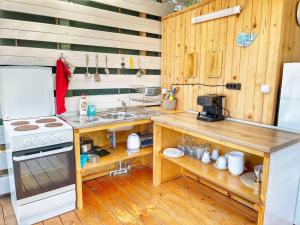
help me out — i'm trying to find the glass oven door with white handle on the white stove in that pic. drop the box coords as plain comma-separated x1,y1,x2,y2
12,143,75,200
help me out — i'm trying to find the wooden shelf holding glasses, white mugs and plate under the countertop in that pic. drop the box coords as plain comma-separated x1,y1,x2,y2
160,153,260,203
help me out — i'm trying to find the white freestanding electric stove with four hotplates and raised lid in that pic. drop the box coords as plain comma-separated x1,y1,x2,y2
0,67,76,225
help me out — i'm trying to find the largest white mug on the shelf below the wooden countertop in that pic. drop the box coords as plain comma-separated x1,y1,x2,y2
227,151,245,176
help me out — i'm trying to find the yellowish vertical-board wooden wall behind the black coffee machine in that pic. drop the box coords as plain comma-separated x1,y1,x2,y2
162,0,300,124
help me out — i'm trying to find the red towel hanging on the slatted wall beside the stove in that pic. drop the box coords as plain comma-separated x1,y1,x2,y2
56,59,71,115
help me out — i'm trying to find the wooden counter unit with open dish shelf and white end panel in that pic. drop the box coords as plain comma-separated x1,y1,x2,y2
152,113,300,225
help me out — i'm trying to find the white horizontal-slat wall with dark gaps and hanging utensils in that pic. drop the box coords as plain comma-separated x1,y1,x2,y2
0,0,172,143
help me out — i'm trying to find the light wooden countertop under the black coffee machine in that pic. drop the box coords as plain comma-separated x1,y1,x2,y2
152,113,300,153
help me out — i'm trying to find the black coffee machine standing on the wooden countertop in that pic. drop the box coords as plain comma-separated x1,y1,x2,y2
197,95,225,122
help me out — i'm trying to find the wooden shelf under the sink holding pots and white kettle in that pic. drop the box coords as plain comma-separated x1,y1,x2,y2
81,143,153,175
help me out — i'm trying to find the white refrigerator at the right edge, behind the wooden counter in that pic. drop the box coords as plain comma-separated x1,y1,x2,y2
278,63,300,225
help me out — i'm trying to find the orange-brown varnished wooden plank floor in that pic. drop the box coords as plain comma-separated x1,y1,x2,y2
0,168,255,225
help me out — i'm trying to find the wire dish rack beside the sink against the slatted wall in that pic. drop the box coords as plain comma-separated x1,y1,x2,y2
129,85,161,107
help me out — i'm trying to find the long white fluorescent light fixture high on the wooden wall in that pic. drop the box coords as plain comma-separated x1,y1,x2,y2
192,6,241,24
